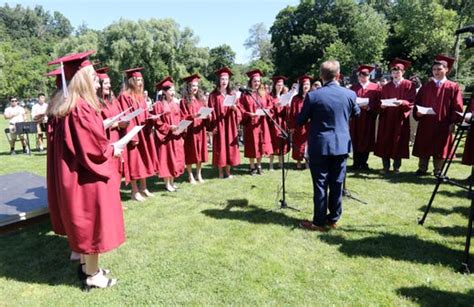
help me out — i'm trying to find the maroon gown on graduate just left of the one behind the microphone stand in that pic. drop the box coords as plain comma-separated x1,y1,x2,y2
240,93,273,158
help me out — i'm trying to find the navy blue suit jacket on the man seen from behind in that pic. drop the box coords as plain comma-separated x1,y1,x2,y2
298,81,360,157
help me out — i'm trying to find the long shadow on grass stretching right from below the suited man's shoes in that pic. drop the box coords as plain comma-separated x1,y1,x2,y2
320,232,462,270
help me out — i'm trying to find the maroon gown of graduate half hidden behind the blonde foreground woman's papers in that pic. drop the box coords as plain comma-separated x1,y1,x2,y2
100,99,130,188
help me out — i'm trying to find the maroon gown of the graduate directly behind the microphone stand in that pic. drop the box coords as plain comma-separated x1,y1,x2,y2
269,96,290,155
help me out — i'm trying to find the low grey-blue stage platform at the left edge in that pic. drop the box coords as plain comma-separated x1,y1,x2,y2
0,172,48,227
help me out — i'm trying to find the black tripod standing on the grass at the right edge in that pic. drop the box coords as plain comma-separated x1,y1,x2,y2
418,100,474,274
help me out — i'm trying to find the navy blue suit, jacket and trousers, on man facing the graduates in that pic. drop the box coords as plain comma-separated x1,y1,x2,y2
297,81,360,226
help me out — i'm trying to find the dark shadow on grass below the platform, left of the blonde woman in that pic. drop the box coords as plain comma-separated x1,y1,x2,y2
0,221,80,287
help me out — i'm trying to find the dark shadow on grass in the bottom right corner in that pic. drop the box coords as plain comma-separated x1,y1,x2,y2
397,286,474,307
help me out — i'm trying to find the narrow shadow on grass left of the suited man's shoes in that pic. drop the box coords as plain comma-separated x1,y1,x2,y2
201,199,301,228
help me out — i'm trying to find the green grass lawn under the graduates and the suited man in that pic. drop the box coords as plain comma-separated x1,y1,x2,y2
0,117,474,306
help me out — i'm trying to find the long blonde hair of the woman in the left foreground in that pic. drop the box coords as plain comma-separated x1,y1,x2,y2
47,66,101,117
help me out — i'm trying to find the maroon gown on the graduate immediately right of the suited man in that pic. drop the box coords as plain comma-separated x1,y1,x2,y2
349,82,382,153
